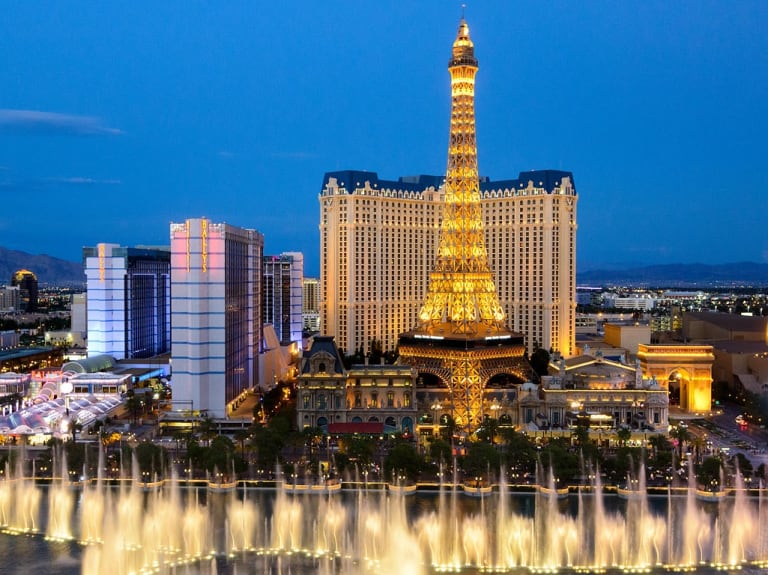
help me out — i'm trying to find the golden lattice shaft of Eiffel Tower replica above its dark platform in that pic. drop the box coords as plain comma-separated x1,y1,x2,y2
419,18,507,335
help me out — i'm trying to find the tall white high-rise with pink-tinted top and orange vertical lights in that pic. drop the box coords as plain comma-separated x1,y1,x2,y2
171,218,264,417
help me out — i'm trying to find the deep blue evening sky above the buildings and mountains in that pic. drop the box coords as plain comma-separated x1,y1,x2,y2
0,0,768,275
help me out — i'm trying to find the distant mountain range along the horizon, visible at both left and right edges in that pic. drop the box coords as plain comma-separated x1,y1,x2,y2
0,246,768,288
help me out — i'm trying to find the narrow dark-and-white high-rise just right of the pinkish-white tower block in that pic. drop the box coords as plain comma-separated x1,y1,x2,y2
262,252,304,346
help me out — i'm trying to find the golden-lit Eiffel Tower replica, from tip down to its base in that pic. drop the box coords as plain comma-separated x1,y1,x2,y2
398,18,531,432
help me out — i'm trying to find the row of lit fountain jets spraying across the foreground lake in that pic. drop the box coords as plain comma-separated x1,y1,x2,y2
0,460,768,575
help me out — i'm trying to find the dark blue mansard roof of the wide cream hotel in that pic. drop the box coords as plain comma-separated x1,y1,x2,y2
323,170,576,194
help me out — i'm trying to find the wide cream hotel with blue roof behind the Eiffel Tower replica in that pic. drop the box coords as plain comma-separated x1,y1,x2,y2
319,170,578,356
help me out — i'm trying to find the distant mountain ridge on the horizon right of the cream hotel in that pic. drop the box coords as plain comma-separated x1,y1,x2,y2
576,262,768,287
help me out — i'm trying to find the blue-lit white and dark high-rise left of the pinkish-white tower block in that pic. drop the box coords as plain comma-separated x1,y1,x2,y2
84,243,171,359
